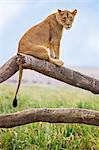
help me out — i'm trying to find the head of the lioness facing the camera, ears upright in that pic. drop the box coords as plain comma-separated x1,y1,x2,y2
56,9,77,29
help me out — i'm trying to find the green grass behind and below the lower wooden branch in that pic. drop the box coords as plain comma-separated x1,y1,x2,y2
0,85,99,150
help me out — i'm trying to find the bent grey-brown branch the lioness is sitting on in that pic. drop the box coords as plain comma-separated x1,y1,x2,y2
0,55,99,94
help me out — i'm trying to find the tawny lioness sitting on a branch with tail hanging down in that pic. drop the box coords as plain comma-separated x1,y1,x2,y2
13,9,77,107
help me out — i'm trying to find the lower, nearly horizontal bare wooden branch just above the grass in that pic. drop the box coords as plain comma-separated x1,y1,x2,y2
0,108,99,128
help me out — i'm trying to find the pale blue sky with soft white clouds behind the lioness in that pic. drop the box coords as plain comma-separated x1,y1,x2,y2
0,0,99,67
